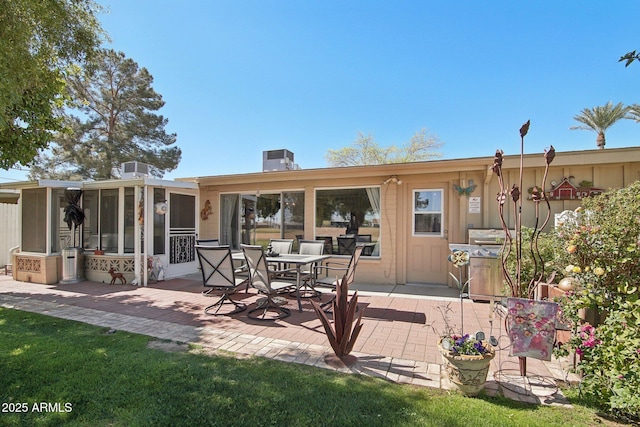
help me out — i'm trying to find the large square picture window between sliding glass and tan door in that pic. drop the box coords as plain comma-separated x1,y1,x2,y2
315,187,380,256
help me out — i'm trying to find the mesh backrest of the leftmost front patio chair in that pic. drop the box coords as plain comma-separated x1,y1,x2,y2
196,245,236,288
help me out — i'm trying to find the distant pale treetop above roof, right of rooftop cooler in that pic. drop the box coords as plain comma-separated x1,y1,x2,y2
325,129,442,166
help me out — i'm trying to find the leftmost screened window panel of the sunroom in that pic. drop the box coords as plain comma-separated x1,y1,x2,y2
22,188,47,253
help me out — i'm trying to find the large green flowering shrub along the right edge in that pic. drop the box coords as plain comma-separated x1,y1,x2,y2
554,182,640,418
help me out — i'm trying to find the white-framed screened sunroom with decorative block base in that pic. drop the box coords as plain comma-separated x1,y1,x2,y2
6,177,198,285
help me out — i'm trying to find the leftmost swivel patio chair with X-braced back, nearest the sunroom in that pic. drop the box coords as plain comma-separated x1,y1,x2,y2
195,245,248,316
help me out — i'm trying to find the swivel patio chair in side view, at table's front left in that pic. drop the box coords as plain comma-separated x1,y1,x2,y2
240,245,295,320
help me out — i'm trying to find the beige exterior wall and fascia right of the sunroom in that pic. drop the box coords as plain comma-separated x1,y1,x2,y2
184,147,640,286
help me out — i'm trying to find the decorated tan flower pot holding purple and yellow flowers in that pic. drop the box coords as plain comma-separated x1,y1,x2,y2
438,340,496,396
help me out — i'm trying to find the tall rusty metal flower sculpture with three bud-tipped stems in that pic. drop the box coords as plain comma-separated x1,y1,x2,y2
492,120,555,376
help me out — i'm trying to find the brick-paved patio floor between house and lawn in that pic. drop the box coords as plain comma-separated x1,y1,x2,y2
0,274,576,405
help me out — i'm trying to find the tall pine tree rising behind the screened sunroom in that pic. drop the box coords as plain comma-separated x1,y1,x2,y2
31,50,182,180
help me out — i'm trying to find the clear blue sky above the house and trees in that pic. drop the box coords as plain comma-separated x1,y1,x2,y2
0,0,640,182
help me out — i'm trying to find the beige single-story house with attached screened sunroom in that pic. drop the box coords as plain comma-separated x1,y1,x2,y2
0,147,640,286
